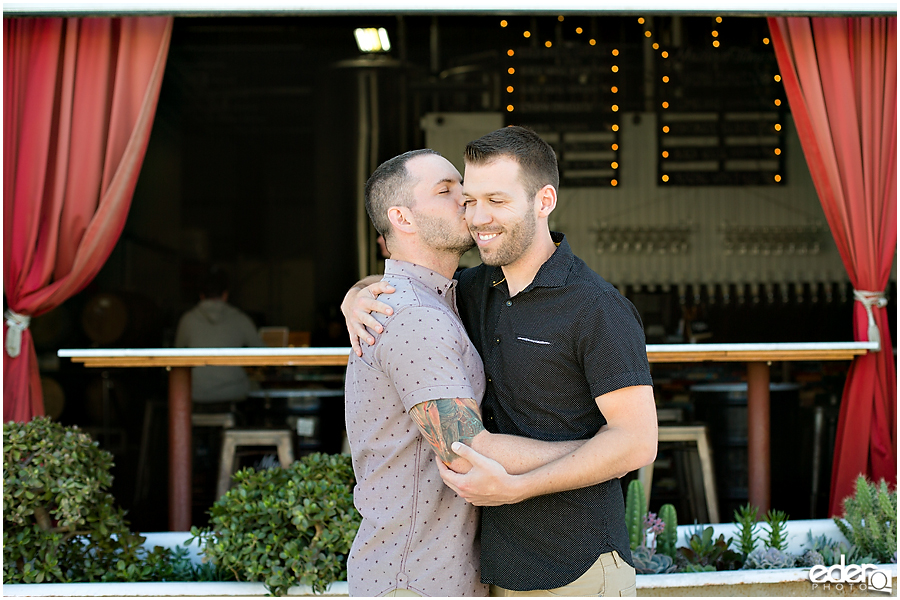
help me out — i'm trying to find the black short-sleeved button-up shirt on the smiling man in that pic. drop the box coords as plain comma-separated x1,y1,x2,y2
458,233,652,591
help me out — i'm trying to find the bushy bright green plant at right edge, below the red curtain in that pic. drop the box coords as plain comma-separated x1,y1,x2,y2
834,475,897,563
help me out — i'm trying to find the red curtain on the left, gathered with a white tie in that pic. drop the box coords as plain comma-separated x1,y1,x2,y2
3,17,172,421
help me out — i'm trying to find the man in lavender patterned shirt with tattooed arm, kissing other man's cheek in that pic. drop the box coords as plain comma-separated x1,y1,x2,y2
345,150,584,596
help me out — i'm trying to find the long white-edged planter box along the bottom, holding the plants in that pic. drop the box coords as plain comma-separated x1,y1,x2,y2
3,519,897,597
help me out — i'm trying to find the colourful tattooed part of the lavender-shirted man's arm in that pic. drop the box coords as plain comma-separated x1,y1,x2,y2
409,398,484,465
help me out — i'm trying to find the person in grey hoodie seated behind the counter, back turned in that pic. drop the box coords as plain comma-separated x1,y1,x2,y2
175,269,263,412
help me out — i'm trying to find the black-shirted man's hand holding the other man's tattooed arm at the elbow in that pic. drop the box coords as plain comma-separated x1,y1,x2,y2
435,442,526,506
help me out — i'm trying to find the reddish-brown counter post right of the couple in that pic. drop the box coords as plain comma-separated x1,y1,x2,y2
747,362,772,517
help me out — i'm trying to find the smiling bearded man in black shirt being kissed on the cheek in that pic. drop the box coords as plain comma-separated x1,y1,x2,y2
345,127,657,595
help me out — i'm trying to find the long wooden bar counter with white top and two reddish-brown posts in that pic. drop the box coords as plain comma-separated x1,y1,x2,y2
58,342,877,531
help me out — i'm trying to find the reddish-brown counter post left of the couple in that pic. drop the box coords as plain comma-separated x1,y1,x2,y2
169,367,191,531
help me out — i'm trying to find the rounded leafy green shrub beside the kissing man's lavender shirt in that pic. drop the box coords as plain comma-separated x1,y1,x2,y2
187,454,361,596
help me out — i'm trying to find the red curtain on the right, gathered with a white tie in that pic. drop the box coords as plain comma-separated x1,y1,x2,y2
769,17,897,515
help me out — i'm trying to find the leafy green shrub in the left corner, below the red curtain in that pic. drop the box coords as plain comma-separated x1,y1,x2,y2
3,417,202,583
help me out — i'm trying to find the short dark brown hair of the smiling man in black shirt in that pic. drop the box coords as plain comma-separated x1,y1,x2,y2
465,125,559,198
